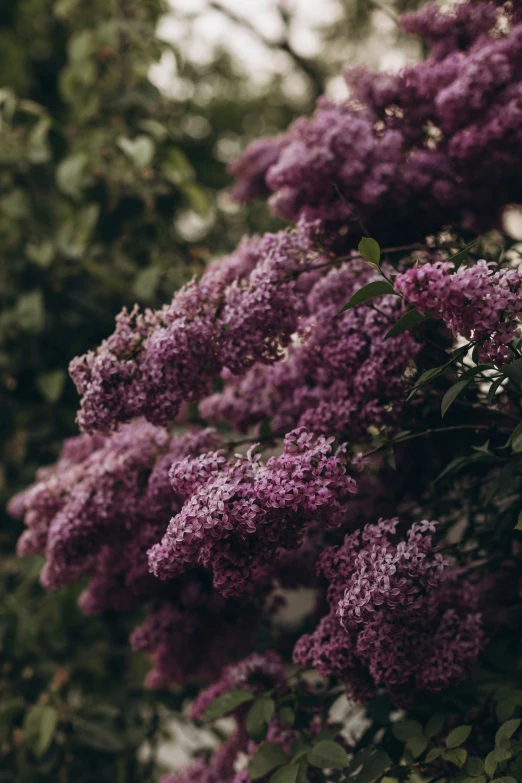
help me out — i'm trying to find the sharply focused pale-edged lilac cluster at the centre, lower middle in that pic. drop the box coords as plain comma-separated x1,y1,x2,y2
149,429,357,596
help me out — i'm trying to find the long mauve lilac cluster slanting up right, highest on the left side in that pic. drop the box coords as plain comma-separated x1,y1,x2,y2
70,230,317,432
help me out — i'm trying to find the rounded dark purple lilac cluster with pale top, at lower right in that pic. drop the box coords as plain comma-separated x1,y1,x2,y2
294,519,483,705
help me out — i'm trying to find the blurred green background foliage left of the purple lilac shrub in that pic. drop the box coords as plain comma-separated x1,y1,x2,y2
0,0,422,783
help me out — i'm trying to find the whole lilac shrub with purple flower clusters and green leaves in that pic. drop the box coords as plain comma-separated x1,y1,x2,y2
10,0,522,783
